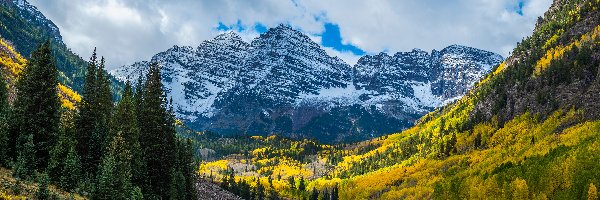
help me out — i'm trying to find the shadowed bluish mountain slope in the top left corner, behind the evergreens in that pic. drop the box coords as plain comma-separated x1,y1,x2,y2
0,0,122,95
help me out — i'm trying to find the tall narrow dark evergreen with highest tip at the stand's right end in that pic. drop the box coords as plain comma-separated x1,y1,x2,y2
140,63,176,199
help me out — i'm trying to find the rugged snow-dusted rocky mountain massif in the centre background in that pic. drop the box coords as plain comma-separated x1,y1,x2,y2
111,25,502,142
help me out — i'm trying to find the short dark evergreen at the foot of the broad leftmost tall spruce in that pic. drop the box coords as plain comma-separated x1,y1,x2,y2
13,134,36,180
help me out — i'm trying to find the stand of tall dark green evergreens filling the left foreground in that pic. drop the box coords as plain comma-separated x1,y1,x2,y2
0,42,196,199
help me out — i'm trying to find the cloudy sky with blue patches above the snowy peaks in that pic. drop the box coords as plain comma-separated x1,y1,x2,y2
31,0,551,68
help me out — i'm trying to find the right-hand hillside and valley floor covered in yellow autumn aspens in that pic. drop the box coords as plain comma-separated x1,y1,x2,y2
198,0,600,199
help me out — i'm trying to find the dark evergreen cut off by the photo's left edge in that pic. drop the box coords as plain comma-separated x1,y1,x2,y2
0,77,9,167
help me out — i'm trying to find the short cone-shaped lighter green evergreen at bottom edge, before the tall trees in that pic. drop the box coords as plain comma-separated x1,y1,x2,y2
93,133,134,199
